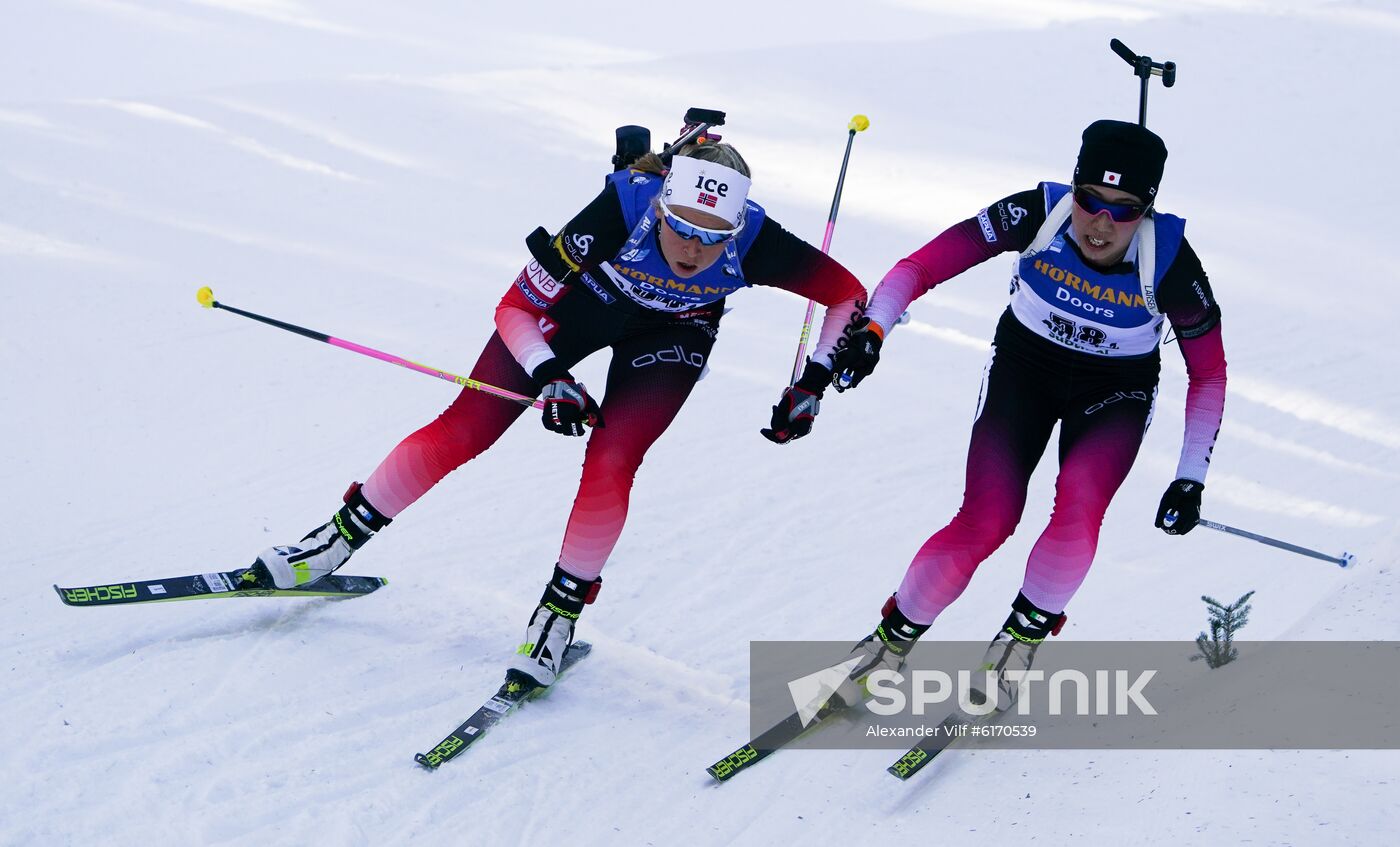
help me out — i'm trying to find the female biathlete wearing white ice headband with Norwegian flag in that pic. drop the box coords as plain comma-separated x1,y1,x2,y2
258,141,865,685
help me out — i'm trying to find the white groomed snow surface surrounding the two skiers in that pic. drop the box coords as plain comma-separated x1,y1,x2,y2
0,0,1400,846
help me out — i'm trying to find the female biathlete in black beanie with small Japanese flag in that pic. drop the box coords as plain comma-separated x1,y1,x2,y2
833,120,1225,710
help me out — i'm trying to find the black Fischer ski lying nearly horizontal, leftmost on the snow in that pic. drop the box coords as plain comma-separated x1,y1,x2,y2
53,564,389,606
